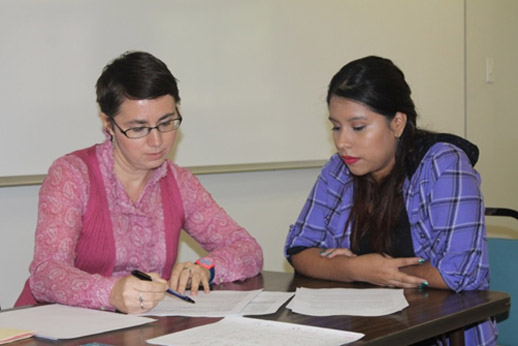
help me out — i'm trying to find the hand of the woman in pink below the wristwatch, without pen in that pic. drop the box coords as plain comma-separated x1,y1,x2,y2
169,262,210,296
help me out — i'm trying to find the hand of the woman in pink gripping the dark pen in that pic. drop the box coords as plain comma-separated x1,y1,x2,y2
110,273,167,314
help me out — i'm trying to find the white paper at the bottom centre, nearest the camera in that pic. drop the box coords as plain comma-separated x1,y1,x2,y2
147,316,364,346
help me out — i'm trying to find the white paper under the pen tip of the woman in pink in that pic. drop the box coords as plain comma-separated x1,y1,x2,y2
142,290,262,317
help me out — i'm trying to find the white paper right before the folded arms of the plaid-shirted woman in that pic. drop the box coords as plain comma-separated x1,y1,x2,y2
288,287,408,316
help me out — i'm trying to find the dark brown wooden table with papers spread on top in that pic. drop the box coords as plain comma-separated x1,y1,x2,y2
13,271,511,346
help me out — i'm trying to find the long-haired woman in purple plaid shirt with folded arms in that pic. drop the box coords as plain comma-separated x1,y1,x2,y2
285,56,496,345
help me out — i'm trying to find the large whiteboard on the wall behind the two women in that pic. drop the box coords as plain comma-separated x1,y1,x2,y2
0,0,464,177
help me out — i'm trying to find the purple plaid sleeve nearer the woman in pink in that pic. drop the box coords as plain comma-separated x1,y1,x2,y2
284,157,343,260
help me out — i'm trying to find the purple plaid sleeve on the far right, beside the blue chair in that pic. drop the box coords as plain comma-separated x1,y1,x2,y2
420,145,489,292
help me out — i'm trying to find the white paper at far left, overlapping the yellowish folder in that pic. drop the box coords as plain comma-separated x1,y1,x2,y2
0,304,155,340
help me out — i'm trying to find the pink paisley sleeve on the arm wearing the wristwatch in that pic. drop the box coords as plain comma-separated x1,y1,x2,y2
171,164,263,283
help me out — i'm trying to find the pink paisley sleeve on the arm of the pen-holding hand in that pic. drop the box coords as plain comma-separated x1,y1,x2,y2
30,155,115,309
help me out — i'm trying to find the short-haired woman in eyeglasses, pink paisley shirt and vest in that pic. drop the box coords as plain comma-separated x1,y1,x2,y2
15,52,263,313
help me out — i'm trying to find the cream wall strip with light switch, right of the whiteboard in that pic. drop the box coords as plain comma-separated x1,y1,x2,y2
466,0,518,238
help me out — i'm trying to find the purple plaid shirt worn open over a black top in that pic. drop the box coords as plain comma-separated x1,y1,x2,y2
285,143,496,345
